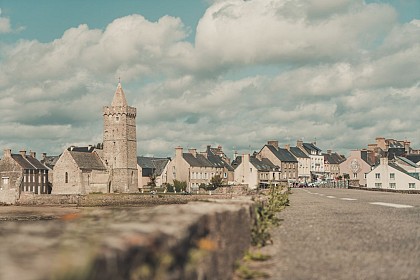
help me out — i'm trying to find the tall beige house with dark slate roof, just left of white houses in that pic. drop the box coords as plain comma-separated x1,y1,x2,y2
258,141,298,182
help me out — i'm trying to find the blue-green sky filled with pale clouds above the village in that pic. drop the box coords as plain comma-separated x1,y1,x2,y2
0,0,420,160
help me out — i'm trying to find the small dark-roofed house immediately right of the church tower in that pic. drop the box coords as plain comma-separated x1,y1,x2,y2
137,156,171,188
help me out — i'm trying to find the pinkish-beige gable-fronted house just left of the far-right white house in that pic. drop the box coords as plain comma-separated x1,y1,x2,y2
340,149,376,187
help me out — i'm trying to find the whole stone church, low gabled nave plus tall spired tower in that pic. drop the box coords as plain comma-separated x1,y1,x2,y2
52,83,138,194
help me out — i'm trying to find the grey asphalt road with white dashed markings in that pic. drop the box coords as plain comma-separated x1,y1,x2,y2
259,188,420,280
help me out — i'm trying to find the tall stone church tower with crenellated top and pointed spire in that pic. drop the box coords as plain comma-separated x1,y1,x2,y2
103,82,138,193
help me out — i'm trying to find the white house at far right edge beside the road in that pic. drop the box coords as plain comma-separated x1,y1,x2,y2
366,157,420,190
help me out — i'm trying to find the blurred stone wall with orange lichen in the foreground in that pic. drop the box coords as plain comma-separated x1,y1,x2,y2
0,198,253,280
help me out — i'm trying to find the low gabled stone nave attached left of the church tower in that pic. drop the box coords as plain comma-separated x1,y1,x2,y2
52,147,111,194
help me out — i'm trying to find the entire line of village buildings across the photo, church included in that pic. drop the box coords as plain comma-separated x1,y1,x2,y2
0,83,420,202
